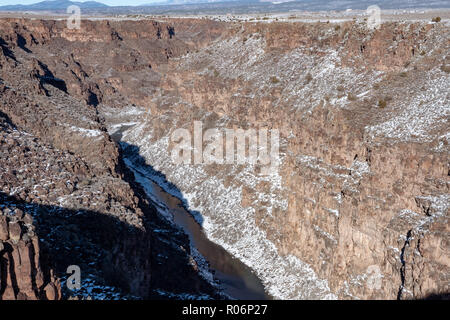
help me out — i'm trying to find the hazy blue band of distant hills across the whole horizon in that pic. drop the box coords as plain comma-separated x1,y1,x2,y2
0,0,450,15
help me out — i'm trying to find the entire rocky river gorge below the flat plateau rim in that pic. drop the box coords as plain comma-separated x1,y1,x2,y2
0,17,450,300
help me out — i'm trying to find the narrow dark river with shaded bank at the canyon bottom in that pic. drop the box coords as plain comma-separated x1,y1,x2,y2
112,126,273,300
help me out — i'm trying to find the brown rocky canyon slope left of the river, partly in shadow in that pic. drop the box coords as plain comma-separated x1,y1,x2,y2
0,20,220,299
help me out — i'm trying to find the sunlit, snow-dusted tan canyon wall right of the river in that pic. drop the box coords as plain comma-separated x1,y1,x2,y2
100,19,449,299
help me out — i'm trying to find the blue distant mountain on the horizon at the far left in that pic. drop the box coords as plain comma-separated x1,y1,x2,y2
0,0,108,11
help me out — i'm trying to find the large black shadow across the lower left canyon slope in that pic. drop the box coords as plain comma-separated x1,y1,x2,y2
0,182,219,299
